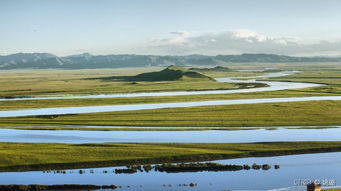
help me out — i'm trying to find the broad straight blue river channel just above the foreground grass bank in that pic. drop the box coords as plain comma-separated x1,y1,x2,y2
0,128,341,144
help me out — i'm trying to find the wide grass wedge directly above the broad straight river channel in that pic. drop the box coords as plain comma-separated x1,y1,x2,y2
0,101,341,127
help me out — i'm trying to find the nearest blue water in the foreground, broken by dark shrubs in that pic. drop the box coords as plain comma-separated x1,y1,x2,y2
0,152,341,191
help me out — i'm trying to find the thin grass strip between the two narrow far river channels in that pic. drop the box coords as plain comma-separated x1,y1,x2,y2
0,88,332,110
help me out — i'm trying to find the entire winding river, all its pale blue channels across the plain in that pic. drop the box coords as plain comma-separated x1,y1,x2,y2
0,72,341,191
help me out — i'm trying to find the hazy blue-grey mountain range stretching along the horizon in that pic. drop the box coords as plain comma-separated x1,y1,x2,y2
0,53,341,69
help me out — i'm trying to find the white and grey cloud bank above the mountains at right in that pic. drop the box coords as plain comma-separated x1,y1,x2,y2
149,30,341,56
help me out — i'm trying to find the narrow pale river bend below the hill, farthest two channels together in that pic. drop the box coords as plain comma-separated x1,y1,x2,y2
0,72,341,117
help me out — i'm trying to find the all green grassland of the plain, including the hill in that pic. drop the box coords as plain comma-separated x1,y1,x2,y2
0,65,341,189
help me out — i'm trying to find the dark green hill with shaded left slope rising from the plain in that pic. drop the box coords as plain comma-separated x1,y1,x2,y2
129,65,213,81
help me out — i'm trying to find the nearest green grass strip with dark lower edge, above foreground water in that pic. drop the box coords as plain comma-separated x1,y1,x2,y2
0,142,341,171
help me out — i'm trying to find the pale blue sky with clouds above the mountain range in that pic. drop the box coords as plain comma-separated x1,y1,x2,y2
0,0,341,56
